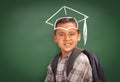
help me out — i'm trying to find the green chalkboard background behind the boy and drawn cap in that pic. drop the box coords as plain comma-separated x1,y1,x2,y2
0,0,120,82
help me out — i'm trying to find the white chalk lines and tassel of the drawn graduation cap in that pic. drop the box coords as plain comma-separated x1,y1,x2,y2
45,6,88,45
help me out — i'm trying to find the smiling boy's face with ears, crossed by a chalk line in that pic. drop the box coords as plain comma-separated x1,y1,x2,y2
54,22,80,52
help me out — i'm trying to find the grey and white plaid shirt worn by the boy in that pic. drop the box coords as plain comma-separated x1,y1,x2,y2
45,53,93,82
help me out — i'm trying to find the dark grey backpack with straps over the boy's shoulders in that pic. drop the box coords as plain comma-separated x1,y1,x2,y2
51,48,105,82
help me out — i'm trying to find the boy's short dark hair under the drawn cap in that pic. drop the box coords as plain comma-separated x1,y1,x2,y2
54,17,80,34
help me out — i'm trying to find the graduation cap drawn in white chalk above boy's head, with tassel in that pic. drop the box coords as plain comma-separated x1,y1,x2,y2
45,6,88,45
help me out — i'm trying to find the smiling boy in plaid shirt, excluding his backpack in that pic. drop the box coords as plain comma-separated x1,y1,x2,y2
45,17,93,82
